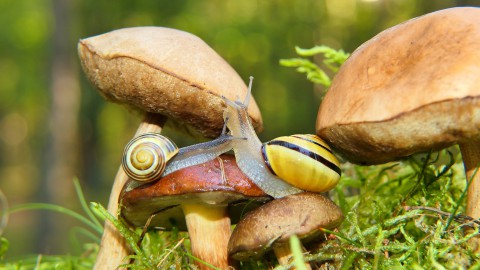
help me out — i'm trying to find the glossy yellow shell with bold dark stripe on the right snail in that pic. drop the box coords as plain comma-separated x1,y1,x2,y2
262,134,341,192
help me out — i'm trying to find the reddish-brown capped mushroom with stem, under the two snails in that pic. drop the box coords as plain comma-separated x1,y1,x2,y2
121,155,270,269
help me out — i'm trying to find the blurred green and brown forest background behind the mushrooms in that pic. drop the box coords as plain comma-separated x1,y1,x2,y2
0,0,479,258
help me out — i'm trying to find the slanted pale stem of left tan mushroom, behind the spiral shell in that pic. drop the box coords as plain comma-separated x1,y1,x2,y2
93,113,167,270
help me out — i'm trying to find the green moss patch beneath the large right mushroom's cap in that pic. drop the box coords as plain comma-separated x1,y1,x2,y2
307,149,480,269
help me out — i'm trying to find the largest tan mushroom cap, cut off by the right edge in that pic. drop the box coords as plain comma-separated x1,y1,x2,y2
316,7,480,164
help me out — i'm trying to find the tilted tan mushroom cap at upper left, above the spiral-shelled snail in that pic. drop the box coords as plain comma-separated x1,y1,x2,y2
78,27,262,138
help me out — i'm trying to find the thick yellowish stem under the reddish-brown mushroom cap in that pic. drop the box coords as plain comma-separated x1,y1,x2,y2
182,204,231,269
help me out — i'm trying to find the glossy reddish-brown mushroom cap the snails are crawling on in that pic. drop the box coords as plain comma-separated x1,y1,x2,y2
120,154,271,230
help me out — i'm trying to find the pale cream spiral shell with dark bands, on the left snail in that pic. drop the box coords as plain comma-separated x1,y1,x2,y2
122,133,178,182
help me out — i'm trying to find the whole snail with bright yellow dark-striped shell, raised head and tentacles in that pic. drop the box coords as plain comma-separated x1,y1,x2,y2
224,78,341,198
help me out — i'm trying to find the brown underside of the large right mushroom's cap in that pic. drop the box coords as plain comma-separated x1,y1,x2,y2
317,97,480,165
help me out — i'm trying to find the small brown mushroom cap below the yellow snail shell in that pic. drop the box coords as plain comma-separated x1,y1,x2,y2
228,192,343,260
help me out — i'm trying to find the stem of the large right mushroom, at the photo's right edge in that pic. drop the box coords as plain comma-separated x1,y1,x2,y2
459,138,480,253
